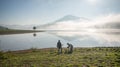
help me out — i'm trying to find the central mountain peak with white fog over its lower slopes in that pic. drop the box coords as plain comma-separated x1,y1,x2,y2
37,15,89,30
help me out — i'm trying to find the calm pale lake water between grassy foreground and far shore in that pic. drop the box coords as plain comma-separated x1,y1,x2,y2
0,29,120,51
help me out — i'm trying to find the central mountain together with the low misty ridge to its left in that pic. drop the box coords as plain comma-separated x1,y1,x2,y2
2,15,89,30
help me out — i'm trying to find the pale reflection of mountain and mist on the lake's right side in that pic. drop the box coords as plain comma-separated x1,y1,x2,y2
47,31,120,47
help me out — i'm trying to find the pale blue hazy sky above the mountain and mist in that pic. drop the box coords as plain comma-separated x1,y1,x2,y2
0,0,120,24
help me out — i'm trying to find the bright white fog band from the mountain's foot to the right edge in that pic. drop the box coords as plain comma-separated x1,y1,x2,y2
43,14,120,30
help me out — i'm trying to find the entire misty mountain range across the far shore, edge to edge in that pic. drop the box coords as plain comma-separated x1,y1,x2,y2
0,15,120,30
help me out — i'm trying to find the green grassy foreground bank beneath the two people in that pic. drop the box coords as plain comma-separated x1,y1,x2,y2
0,47,120,67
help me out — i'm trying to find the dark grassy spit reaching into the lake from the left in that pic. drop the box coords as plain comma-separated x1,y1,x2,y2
0,29,43,35
